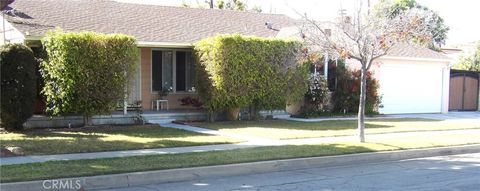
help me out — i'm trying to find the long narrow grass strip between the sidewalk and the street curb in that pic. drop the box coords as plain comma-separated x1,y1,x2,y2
0,129,480,182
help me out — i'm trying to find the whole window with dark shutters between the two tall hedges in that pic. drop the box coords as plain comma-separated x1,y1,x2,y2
152,50,195,92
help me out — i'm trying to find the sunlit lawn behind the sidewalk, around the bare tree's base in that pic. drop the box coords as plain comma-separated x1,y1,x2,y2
194,118,480,139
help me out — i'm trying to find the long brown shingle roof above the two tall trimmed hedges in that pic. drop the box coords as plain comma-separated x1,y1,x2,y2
5,0,295,43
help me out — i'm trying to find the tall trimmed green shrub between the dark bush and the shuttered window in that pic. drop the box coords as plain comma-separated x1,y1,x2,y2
41,30,138,125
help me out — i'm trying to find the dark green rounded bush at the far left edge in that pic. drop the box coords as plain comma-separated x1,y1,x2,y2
0,44,37,130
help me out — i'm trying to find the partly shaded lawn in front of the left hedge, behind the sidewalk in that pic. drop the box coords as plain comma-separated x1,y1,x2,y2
0,125,238,155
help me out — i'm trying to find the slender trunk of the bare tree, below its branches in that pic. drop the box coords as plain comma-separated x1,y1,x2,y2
357,66,367,143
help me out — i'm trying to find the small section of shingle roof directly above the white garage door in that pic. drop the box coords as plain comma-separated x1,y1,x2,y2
387,43,450,60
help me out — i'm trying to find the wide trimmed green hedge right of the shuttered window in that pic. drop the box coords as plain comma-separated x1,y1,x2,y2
195,34,308,115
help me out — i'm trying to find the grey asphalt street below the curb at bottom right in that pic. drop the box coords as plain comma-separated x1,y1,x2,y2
99,153,480,191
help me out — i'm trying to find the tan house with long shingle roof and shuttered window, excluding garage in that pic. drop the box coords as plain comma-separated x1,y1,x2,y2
2,0,295,110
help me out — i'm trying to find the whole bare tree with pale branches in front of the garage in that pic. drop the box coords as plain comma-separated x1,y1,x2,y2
301,1,434,142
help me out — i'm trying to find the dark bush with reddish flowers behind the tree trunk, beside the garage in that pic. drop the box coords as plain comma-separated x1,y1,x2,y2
332,62,380,114
